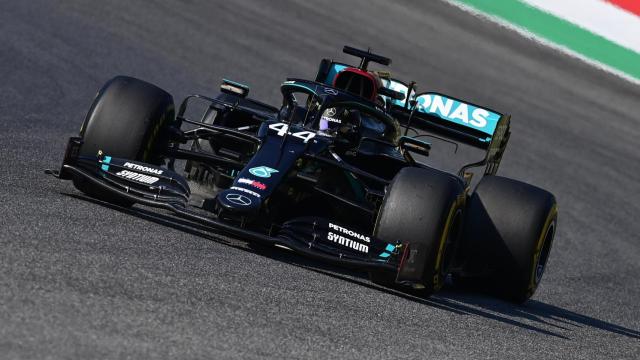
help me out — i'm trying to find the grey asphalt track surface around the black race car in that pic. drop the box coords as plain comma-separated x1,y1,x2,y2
0,0,640,359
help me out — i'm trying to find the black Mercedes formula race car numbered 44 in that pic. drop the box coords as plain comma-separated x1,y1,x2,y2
48,46,557,302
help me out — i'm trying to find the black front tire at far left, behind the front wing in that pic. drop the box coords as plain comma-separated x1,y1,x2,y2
73,76,175,207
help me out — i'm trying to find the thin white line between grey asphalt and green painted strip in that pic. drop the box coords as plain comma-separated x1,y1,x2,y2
441,0,640,86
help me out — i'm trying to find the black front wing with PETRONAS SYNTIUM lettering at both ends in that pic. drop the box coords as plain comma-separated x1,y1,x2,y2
46,138,404,274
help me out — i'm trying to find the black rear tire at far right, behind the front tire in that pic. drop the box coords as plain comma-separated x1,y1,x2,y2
454,176,557,303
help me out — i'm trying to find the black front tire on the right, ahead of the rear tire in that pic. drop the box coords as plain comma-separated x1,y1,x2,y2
369,168,465,295
